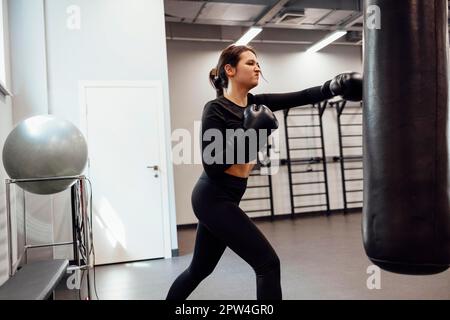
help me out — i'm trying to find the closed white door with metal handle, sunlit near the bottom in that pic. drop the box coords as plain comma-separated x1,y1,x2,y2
84,82,164,264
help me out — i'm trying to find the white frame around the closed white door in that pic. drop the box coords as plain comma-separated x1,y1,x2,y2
78,80,172,259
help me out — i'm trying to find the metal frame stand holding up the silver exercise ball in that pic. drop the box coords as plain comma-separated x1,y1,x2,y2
5,176,93,299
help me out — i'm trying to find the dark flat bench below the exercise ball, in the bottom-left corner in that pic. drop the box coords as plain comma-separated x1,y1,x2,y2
0,259,69,300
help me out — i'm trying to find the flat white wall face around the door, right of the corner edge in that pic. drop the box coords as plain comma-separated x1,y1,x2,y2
45,0,177,256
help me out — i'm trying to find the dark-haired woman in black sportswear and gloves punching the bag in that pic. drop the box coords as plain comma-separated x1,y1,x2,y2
167,45,362,300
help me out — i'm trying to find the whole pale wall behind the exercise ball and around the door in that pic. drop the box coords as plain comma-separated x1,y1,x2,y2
5,0,177,264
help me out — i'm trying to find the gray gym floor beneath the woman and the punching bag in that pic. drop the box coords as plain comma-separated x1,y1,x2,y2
56,213,450,300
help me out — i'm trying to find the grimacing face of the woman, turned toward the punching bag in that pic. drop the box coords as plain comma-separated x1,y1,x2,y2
227,51,261,90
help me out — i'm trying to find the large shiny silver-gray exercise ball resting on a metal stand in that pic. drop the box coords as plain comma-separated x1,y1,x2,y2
3,115,88,194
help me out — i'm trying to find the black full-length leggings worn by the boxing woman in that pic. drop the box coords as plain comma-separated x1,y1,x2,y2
166,172,282,300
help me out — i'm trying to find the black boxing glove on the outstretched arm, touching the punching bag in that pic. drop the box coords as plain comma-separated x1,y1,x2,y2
324,72,363,101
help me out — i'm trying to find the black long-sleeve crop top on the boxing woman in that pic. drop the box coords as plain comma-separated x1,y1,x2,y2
200,86,333,178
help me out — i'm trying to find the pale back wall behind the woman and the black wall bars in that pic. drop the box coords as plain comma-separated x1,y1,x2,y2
167,40,362,224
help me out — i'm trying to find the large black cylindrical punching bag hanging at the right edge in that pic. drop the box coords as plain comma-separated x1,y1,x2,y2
362,0,450,274
